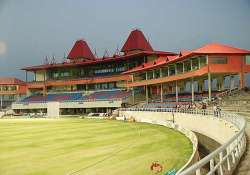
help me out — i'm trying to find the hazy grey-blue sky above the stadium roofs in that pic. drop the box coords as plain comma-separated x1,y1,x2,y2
0,0,250,78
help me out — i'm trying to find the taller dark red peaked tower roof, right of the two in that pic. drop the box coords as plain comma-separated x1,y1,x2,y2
121,29,153,52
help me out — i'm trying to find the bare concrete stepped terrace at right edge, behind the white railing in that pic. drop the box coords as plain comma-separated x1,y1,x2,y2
219,91,250,175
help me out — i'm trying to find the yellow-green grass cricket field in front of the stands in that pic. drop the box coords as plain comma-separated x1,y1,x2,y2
0,119,192,175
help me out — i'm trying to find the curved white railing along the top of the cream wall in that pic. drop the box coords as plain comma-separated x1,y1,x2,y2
120,108,246,175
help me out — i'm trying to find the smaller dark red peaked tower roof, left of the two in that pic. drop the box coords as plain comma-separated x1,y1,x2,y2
67,40,95,60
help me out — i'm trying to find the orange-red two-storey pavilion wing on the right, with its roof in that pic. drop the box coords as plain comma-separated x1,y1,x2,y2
123,43,250,103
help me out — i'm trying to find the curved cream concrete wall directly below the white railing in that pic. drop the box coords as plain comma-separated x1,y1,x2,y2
119,111,239,144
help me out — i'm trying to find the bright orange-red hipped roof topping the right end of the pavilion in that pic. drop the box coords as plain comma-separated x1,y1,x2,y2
192,43,250,54
